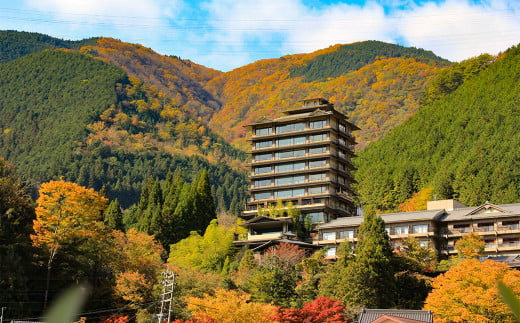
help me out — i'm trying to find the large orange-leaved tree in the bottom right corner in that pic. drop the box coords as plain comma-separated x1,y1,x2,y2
424,259,520,323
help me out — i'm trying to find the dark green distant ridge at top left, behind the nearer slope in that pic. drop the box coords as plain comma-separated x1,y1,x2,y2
0,30,96,63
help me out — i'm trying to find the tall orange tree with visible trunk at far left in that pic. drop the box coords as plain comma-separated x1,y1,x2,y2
31,181,107,305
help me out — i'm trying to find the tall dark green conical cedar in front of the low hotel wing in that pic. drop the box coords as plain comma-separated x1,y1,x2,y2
345,210,396,308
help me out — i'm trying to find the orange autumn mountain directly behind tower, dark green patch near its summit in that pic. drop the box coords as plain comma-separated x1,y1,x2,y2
207,41,447,149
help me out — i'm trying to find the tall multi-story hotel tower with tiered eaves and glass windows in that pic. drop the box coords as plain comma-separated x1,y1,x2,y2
235,98,359,248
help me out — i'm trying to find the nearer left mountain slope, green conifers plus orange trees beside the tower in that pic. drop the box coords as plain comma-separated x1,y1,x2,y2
0,50,245,214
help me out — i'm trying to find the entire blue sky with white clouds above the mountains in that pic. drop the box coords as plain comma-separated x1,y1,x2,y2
0,0,520,71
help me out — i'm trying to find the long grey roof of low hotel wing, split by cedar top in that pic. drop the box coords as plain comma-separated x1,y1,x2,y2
318,210,446,229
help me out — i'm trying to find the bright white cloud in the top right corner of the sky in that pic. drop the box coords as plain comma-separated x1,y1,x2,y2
392,0,520,61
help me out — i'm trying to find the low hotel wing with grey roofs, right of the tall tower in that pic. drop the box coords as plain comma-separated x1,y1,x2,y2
314,200,520,259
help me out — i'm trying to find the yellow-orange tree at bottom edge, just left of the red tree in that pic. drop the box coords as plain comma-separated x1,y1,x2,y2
186,289,278,323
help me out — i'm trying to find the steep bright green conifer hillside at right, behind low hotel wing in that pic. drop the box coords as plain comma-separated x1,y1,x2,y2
355,46,520,210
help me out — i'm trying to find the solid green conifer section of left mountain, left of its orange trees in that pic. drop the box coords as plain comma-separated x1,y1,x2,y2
0,50,128,180
